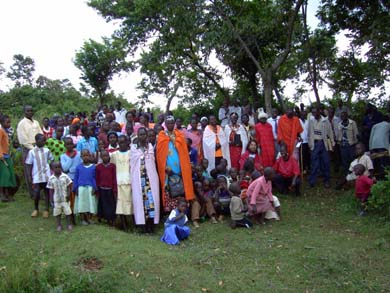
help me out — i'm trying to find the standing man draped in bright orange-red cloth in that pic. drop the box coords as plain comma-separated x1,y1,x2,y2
278,108,303,159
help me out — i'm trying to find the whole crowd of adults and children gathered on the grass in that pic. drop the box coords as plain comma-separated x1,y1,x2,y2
0,99,390,244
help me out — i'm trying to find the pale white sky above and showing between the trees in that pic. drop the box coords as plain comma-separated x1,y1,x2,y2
0,0,338,107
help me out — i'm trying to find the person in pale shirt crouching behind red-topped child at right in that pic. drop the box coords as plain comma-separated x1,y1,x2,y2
336,143,374,190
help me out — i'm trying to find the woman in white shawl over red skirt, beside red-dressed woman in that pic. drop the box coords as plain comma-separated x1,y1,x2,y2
224,112,248,169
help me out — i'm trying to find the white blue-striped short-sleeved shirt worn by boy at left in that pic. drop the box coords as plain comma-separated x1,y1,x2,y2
26,146,54,184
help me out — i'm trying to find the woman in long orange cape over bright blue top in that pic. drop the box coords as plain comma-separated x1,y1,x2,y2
156,116,194,212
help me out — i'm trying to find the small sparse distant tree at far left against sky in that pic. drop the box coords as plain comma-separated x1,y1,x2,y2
7,54,35,87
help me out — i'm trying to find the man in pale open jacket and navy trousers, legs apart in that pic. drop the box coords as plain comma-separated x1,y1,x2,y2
308,108,335,188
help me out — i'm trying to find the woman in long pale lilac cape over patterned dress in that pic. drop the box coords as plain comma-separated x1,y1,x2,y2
130,127,160,232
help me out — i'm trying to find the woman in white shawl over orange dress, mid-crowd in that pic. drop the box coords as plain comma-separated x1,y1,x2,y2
202,115,230,172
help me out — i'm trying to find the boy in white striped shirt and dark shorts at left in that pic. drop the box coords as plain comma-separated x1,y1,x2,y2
25,133,53,218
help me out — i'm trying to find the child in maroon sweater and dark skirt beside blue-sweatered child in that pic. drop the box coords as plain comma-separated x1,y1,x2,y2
96,151,117,226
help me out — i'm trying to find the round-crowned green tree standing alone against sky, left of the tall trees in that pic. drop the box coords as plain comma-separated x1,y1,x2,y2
74,38,131,104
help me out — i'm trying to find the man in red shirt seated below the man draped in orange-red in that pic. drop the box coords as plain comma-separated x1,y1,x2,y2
273,146,301,196
